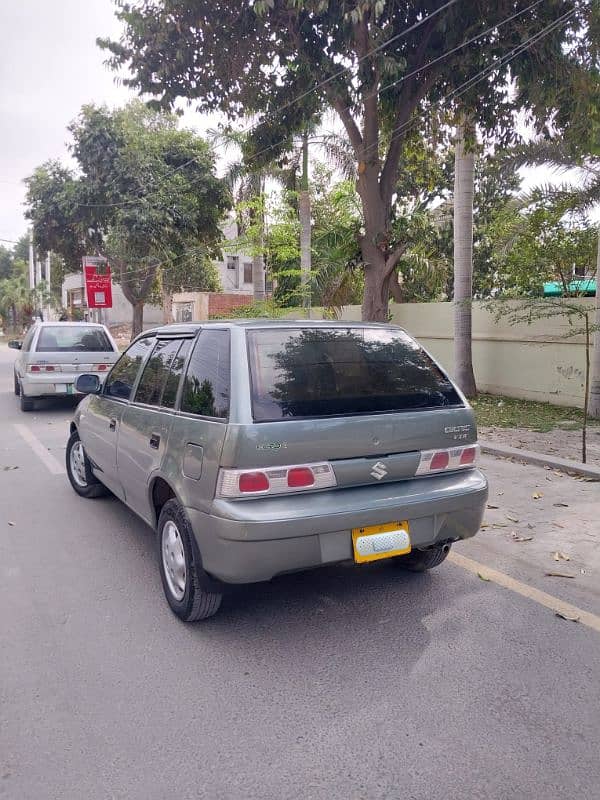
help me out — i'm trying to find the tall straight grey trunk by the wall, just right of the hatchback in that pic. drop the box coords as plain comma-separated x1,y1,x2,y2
454,123,477,397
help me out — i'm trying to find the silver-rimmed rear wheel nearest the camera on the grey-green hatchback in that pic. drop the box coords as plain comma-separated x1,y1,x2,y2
157,500,223,622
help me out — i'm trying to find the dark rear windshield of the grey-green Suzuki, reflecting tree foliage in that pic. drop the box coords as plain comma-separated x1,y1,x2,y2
247,328,462,422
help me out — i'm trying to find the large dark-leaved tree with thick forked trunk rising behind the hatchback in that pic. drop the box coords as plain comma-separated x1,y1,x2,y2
100,0,595,320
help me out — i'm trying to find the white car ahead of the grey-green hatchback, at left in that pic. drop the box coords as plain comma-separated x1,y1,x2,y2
8,322,119,411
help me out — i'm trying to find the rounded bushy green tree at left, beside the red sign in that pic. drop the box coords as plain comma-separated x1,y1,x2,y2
28,102,230,336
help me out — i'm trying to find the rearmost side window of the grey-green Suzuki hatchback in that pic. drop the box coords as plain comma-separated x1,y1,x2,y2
181,330,229,418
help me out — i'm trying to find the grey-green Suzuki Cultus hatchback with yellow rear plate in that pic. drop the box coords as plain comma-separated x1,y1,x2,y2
66,320,488,622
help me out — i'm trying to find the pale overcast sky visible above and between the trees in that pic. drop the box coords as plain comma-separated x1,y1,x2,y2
0,0,592,246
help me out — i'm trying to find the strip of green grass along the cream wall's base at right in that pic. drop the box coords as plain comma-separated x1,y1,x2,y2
471,394,600,433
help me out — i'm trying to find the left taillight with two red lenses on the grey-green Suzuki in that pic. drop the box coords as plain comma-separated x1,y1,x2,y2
217,462,336,497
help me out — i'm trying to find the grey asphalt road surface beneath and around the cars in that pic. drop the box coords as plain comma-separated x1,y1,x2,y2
0,346,600,800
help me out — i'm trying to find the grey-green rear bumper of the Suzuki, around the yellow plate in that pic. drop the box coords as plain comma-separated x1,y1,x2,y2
187,469,488,583
